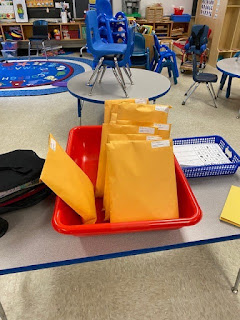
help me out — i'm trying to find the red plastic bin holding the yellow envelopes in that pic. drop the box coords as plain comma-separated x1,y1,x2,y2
52,126,202,236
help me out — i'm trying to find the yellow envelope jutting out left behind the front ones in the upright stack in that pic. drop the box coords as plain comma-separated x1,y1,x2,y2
95,123,160,197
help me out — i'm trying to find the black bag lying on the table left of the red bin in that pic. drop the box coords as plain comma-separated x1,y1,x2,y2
0,150,51,214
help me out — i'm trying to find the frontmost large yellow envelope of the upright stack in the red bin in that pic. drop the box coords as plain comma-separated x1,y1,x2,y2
106,141,179,222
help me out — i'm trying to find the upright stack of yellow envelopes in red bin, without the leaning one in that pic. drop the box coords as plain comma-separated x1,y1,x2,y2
95,100,178,222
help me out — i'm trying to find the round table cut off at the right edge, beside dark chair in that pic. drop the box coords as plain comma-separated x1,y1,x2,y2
217,57,240,98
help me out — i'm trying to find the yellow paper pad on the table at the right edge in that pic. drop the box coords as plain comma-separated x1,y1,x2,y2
220,186,240,227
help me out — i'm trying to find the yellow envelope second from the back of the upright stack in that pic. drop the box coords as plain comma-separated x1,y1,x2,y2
117,102,171,123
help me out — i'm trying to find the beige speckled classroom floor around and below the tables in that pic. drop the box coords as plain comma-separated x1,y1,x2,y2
0,56,240,320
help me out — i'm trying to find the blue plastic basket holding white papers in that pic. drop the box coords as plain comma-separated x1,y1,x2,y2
173,136,240,178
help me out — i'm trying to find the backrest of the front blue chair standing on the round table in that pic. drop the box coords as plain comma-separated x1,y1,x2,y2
85,10,102,55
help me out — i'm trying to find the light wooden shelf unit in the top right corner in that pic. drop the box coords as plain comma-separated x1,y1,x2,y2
196,0,240,67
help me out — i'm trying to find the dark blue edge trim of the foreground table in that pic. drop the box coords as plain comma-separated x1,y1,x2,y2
0,234,240,275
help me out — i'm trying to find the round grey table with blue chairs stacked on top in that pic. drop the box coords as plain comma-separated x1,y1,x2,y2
67,68,171,122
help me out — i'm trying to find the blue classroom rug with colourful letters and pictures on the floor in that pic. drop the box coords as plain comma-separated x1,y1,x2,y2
0,57,92,97
